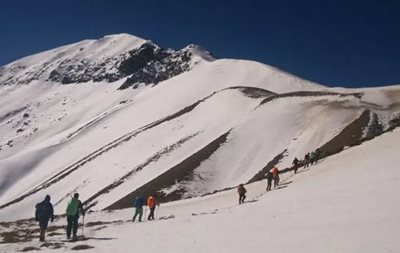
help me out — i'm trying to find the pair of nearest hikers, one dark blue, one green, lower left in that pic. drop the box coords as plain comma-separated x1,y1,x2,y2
35,193,85,242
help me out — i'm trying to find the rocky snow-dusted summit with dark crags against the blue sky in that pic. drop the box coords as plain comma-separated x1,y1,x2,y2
0,35,214,89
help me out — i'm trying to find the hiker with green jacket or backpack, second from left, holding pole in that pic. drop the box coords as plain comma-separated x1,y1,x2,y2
67,193,85,241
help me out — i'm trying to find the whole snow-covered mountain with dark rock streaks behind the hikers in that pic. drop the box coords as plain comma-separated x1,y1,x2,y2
0,34,400,225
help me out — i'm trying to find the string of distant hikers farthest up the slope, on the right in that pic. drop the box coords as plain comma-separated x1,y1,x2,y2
237,148,321,205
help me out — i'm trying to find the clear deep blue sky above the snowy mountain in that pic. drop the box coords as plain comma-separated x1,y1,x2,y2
0,0,400,87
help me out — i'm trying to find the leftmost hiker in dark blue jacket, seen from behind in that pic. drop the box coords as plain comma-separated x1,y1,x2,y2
35,195,54,242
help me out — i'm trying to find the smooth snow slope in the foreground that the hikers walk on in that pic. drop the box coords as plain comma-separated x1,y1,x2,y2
2,129,400,253
